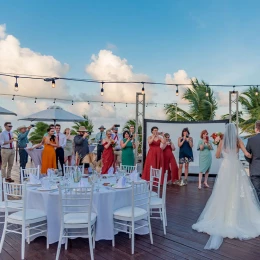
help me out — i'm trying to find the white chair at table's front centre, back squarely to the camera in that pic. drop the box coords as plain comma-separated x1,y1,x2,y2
56,186,97,260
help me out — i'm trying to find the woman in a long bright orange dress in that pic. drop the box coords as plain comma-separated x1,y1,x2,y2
30,128,59,174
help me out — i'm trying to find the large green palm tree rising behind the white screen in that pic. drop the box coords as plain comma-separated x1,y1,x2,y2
165,79,218,121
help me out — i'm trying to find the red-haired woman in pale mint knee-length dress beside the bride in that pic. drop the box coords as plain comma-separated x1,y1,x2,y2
197,130,213,190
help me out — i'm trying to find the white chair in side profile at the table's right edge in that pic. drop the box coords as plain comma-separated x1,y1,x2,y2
150,171,168,235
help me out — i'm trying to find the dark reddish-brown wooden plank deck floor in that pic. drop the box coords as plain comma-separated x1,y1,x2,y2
0,164,260,260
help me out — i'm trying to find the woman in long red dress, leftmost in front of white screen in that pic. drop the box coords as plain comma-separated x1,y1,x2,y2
142,126,165,181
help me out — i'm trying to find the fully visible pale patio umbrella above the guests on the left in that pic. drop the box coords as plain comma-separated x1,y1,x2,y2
19,106,86,124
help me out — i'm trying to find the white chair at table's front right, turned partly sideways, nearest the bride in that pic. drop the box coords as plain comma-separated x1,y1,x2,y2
112,182,153,254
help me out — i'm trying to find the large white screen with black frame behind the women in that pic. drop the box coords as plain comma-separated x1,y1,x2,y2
145,119,227,174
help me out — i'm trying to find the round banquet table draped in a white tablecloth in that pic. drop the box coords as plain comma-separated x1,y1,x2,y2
27,177,148,244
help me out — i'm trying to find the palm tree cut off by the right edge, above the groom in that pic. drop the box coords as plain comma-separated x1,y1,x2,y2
238,86,260,137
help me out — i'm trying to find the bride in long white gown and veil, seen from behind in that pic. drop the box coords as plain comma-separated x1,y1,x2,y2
192,124,260,249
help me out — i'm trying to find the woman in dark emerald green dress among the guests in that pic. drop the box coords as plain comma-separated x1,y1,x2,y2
120,131,135,166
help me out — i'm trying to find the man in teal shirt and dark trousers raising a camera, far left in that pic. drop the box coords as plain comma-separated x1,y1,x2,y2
17,125,32,169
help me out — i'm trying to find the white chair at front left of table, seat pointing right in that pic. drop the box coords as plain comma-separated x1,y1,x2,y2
0,181,49,259
